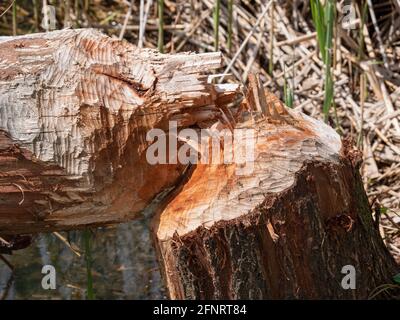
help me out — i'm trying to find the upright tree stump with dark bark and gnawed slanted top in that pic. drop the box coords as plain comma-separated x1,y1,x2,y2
153,81,398,299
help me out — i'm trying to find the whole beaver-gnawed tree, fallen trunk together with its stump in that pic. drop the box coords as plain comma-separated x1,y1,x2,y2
0,30,396,298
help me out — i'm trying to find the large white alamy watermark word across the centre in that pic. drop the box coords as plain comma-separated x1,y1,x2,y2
146,121,255,175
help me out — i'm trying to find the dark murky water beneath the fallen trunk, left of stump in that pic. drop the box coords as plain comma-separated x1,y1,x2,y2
0,217,165,300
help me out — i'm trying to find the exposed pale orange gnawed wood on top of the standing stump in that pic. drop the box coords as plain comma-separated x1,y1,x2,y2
153,102,341,239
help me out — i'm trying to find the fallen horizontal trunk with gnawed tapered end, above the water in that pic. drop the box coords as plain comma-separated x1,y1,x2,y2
0,29,238,235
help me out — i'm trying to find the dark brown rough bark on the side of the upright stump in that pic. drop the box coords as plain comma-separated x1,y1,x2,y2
155,151,399,299
